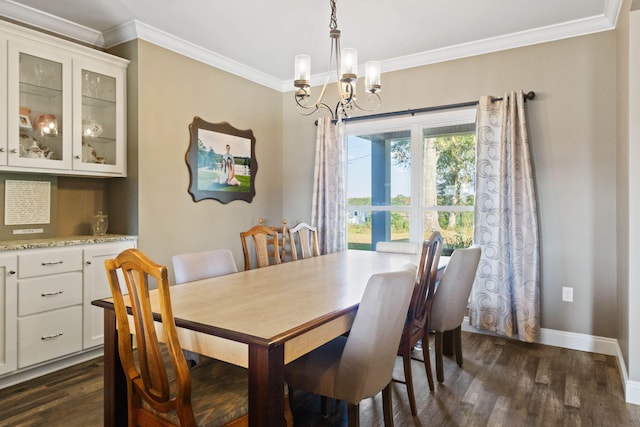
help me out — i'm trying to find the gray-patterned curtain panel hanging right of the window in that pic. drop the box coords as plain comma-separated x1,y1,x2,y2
470,91,540,342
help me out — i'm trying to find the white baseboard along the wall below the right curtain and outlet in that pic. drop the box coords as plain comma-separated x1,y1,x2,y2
462,317,640,405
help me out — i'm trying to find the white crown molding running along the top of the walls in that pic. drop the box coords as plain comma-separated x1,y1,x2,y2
0,0,623,93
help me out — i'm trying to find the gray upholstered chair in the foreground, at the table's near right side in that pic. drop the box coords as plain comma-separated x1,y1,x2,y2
285,268,415,427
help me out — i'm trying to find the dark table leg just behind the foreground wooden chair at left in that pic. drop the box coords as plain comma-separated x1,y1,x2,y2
104,309,127,427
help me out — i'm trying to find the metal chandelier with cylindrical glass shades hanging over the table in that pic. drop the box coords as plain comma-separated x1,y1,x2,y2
293,0,382,120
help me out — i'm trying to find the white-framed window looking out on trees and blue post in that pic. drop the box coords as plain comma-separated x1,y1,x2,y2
346,109,475,254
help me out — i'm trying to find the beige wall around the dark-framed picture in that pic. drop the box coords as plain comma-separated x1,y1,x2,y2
128,41,282,278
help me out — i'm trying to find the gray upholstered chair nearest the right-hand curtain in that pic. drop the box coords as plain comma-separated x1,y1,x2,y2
429,246,481,382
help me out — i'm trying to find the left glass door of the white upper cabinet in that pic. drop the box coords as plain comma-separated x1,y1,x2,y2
7,41,71,169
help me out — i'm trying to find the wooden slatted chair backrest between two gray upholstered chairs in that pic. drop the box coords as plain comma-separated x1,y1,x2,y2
405,231,443,336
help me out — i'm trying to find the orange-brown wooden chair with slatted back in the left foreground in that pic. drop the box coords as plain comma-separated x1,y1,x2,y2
105,249,264,426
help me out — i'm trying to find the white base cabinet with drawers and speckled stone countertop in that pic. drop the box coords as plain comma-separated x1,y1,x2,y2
0,238,137,387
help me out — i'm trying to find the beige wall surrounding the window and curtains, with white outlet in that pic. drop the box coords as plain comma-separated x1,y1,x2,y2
283,31,618,337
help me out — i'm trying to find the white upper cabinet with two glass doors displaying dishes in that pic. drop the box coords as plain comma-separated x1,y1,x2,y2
0,22,128,177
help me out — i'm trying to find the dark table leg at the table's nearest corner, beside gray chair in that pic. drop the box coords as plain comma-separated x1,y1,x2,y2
249,344,285,427
